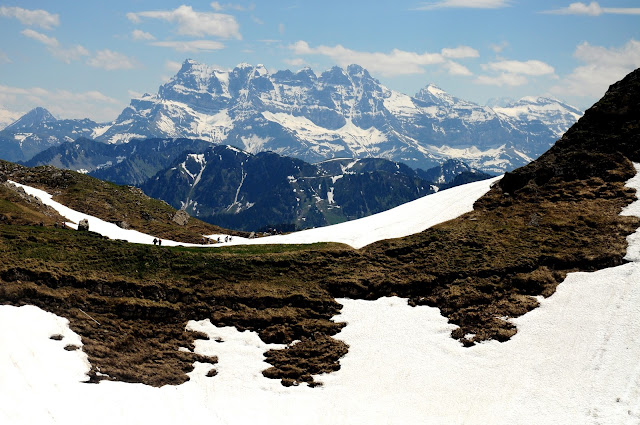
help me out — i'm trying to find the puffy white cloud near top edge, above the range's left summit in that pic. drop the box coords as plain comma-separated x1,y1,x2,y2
127,5,242,40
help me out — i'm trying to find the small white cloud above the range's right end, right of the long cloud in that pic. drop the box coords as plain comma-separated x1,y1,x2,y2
475,60,555,87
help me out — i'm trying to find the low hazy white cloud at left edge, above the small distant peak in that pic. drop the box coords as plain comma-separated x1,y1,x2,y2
0,85,124,121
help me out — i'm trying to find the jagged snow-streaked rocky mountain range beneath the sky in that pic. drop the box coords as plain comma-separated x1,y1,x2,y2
2,60,582,172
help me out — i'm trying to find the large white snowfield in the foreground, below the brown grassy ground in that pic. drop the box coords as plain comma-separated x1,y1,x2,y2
0,165,640,425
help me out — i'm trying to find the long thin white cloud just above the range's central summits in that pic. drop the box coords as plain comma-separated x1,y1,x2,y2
289,41,478,76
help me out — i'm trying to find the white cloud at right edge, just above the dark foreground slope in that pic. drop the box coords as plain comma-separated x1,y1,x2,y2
551,40,640,99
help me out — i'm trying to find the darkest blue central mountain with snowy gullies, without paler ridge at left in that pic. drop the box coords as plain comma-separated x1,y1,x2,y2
141,146,490,231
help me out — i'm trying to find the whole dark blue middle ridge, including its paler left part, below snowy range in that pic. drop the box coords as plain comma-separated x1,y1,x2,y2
25,139,489,231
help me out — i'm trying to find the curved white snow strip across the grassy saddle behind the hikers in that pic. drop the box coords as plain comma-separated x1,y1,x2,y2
11,177,499,248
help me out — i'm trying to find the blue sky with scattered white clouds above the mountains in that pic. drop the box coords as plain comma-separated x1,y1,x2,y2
0,0,640,121
